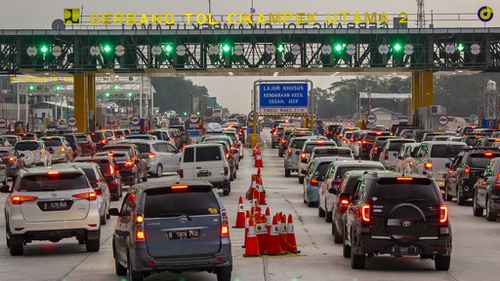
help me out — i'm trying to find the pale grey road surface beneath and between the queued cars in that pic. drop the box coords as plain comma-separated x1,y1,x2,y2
0,129,500,281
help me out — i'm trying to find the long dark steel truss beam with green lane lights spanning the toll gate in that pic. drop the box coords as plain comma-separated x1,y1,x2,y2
0,28,500,74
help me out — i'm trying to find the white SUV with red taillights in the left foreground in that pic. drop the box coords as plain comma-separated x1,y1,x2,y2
0,167,101,256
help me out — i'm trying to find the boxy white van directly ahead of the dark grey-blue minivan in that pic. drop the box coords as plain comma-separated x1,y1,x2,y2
179,143,231,195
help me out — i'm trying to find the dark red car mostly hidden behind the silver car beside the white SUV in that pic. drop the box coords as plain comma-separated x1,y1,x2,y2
74,156,122,201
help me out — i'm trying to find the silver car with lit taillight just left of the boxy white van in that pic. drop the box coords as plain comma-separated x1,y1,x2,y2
123,140,182,177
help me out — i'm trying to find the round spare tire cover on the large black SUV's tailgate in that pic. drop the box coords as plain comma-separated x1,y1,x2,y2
386,203,426,244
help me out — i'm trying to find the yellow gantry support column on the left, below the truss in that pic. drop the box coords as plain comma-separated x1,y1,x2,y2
74,72,96,133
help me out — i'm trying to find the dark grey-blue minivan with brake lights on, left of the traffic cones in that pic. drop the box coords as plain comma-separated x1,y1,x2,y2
109,182,233,281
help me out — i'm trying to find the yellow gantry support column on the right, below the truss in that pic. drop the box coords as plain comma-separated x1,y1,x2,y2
409,70,434,126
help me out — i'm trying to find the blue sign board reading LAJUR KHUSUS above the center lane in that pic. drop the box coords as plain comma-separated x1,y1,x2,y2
259,83,309,114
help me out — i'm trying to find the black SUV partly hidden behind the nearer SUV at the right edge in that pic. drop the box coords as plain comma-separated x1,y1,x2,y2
444,147,500,205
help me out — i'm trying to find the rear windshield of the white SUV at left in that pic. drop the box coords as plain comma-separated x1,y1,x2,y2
19,173,88,191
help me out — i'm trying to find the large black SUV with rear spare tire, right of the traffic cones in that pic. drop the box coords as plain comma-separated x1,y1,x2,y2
339,172,452,270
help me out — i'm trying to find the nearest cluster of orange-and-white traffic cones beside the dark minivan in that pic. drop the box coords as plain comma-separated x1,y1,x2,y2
234,196,300,257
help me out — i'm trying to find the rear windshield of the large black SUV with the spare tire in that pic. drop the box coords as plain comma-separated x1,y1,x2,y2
372,181,439,204
